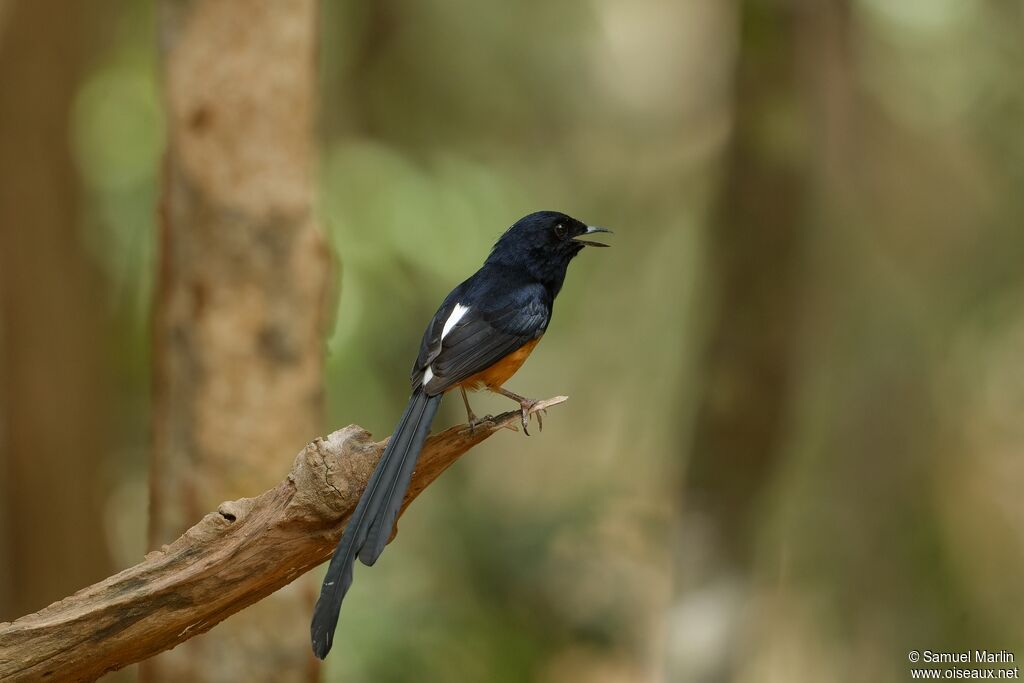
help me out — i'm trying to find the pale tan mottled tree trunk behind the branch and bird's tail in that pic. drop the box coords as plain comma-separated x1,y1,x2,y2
143,0,330,681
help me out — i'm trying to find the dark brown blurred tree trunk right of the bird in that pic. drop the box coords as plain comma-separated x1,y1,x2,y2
679,0,848,681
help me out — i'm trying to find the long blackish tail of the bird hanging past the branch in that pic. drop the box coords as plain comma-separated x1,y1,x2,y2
310,388,441,659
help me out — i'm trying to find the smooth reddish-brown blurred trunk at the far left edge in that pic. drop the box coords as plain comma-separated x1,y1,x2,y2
0,0,111,621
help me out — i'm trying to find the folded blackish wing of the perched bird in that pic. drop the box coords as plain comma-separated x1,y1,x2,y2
417,285,551,395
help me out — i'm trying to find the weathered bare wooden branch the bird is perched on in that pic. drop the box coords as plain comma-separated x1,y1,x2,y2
0,396,566,682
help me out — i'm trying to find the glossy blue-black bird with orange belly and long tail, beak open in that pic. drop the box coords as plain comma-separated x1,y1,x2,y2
310,211,611,659
